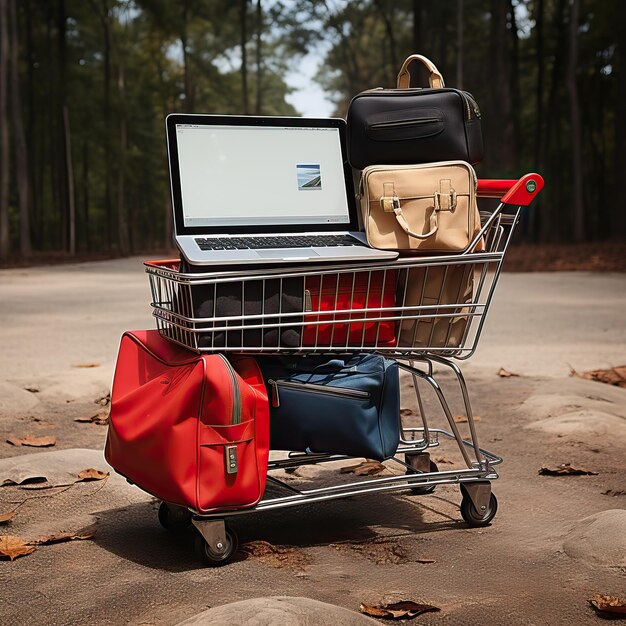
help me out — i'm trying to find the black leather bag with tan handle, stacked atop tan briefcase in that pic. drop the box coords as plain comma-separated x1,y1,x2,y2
347,54,483,170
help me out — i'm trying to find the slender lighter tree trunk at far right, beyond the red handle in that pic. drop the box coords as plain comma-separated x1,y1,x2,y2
567,0,585,241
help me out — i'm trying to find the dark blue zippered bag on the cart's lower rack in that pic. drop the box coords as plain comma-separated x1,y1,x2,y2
258,353,400,461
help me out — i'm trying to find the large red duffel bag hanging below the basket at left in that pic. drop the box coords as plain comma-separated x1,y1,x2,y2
105,330,269,513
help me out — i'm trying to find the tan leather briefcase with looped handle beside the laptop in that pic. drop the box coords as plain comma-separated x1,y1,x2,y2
360,161,481,254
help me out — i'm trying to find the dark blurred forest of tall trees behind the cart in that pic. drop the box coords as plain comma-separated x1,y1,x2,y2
0,0,626,261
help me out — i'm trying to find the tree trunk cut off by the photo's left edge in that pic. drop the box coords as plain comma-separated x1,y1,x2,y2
0,0,10,259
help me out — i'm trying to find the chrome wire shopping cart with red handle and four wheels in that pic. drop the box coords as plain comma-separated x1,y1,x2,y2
145,174,543,565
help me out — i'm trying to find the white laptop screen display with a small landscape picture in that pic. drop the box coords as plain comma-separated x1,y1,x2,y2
176,123,350,227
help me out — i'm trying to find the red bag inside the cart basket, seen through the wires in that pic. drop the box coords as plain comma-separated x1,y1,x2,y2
302,270,397,348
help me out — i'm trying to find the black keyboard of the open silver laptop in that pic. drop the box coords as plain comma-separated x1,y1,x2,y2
196,235,363,250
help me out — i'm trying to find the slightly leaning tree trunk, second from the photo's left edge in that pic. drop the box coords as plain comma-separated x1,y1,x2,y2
9,0,32,257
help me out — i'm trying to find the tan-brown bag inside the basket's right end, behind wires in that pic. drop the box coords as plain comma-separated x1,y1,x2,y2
396,263,474,348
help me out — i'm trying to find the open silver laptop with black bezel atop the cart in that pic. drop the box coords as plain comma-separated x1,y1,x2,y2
166,114,398,265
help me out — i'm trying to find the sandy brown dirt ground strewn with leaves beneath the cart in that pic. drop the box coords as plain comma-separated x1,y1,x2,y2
0,259,626,626
